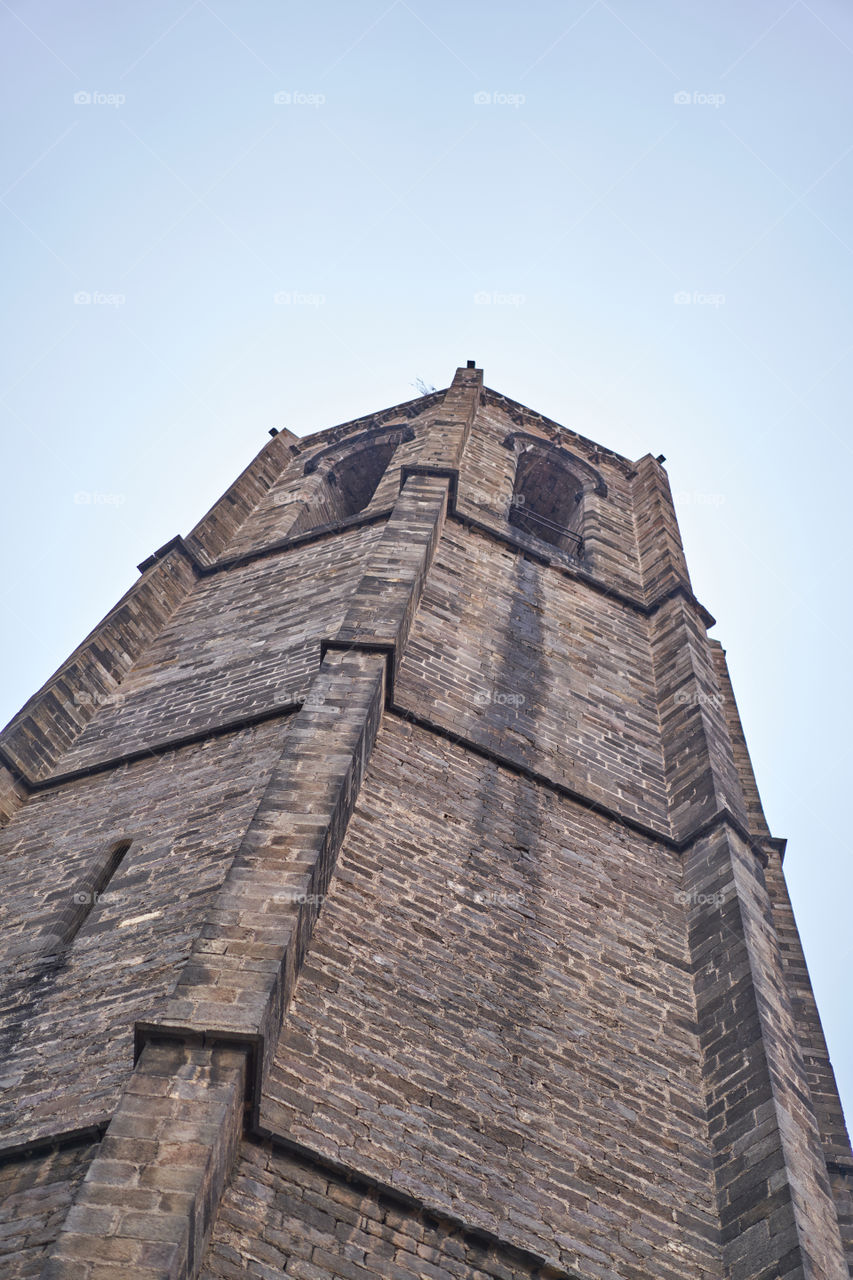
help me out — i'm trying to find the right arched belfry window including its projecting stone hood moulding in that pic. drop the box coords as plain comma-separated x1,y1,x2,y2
503,431,607,557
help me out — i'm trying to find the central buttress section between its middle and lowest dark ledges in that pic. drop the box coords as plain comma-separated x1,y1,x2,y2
137,653,386,1084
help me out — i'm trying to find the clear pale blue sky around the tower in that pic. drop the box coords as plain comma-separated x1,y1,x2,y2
0,0,853,1131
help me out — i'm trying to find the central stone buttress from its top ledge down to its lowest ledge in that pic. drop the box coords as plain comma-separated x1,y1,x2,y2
137,476,447,1084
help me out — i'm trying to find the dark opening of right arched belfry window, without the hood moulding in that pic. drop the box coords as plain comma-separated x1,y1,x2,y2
508,448,584,556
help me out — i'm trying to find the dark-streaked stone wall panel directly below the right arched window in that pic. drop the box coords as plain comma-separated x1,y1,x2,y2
396,524,669,831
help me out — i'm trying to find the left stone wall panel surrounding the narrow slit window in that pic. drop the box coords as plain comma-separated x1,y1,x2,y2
0,722,286,1144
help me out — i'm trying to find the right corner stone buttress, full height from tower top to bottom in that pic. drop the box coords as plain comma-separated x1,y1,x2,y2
634,458,847,1280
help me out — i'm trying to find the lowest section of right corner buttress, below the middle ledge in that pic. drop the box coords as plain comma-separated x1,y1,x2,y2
684,829,847,1280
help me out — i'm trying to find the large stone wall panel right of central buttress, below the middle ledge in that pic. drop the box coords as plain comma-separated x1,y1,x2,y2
261,719,720,1280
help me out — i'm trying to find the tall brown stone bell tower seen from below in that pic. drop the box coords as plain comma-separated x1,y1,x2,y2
0,364,853,1280
